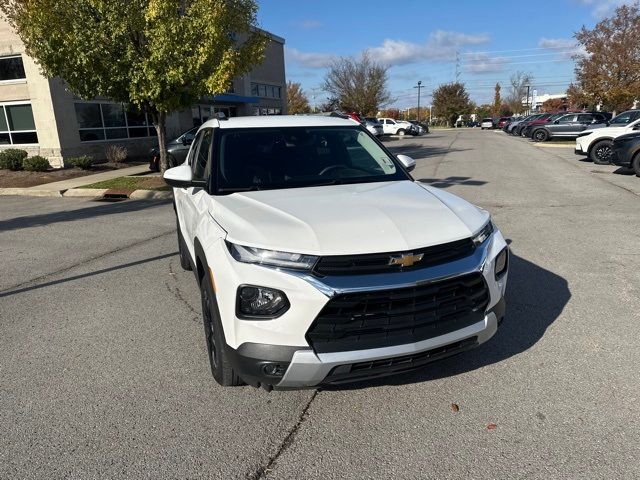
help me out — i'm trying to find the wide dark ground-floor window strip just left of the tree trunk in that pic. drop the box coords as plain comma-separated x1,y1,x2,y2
75,102,157,142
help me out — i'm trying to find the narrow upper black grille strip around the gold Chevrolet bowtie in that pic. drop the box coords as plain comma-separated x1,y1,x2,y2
313,238,475,276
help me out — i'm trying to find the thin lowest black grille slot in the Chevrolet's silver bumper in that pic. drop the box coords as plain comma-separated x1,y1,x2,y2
322,337,478,384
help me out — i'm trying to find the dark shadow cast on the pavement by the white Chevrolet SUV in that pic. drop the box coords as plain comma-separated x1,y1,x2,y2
325,252,571,390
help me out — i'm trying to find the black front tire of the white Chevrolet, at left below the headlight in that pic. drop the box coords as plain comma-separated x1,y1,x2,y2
200,273,244,387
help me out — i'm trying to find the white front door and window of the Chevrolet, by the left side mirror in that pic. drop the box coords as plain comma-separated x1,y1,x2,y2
181,128,213,256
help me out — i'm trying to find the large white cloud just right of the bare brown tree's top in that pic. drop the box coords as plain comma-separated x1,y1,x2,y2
369,30,491,67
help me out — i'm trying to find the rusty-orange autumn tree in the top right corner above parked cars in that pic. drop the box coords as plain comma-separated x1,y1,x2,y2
575,3,640,110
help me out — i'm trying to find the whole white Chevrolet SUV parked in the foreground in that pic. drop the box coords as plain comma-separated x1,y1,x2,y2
164,116,509,389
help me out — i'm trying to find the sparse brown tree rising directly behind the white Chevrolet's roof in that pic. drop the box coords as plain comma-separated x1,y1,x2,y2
324,52,391,116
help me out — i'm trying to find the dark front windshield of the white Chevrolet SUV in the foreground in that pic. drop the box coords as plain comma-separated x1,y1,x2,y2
215,127,410,193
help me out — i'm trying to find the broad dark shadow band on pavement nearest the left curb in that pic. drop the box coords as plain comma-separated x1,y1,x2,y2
0,200,172,232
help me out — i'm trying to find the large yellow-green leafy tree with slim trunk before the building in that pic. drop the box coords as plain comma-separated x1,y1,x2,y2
0,0,267,171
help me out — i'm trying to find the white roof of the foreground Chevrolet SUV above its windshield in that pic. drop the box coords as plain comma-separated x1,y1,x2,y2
202,115,359,128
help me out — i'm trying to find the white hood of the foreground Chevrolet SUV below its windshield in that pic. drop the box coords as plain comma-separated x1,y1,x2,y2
210,180,489,255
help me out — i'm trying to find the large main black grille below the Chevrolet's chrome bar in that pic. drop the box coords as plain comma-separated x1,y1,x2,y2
307,273,489,353
